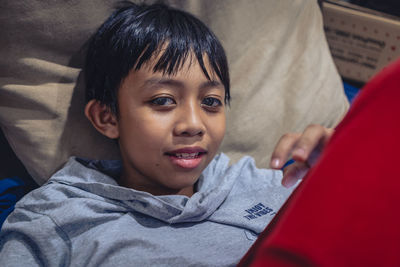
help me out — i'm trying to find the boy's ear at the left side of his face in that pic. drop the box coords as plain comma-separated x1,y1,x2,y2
85,99,119,139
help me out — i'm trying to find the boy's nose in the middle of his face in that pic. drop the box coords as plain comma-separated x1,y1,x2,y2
174,105,206,136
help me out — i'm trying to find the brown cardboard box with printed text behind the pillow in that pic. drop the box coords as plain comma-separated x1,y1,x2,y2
323,1,400,83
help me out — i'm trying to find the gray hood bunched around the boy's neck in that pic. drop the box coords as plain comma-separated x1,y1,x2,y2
48,154,241,224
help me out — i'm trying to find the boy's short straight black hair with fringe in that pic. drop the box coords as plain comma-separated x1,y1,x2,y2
85,2,230,114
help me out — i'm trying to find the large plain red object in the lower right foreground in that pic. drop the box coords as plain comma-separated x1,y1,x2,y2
239,60,400,266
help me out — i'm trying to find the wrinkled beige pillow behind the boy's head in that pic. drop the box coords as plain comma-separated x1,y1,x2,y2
0,0,348,184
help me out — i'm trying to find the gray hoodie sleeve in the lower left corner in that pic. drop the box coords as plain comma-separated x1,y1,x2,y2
0,208,71,267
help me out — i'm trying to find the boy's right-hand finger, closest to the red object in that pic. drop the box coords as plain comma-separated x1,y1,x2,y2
292,125,333,162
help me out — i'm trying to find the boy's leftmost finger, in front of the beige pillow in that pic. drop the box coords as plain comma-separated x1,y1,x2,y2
270,133,300,169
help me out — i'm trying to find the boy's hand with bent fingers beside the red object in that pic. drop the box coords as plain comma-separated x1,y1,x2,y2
270,124,334,187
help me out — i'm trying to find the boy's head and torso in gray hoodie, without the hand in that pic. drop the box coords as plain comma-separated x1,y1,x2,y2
0,4,304,266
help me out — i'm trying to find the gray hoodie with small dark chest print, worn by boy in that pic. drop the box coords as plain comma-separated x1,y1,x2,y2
0,154,292,266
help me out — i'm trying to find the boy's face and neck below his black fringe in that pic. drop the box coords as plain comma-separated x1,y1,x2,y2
116,56,225,196
